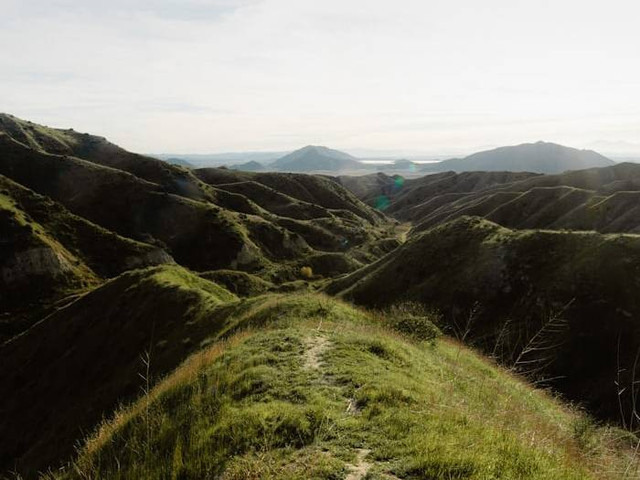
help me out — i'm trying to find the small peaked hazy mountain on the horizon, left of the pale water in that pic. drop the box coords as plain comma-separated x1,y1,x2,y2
270,145,362,172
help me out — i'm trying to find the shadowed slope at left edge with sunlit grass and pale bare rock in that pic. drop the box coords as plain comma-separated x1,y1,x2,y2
0,175,173,342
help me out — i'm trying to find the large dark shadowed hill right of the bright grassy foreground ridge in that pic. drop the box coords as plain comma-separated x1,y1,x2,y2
329,217,640,425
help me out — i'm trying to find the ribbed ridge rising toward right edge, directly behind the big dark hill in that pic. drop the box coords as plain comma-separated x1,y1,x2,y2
410,164,640,233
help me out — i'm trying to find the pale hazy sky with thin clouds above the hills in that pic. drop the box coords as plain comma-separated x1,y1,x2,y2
0,0,640,153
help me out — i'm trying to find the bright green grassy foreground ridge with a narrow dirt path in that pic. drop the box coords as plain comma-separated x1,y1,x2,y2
53,295,638,480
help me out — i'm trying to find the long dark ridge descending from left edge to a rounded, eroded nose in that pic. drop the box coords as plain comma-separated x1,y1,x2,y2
0,134,278,270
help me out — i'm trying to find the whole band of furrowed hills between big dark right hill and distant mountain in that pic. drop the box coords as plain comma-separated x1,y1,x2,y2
339,163,640,233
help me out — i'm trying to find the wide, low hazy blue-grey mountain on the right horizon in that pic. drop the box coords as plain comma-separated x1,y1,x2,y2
423,142,615,173
